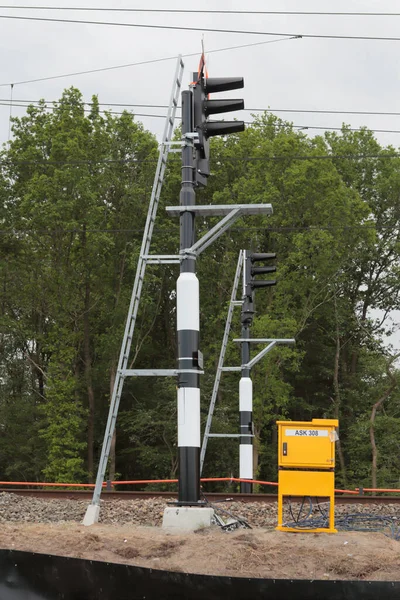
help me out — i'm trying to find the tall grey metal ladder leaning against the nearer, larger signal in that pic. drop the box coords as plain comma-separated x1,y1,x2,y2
88,56,184,505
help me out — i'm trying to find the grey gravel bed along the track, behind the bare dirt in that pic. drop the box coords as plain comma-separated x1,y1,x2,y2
0,492,400,528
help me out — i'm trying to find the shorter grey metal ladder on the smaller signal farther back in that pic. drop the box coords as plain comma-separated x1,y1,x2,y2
200,250,244,474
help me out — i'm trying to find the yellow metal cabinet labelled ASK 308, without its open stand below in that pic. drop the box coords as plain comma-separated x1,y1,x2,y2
277,419,339,469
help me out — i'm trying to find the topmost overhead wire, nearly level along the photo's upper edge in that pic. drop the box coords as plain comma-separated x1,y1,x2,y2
0,4,400,17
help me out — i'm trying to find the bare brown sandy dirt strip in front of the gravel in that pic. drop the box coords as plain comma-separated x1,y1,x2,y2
0,523,400,581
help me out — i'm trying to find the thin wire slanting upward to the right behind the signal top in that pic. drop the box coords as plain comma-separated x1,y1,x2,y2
0,36,300,87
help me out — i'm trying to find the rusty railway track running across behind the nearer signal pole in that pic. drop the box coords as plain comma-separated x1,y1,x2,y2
0,488,400,504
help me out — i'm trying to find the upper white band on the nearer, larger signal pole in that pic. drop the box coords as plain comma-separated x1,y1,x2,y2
176,273,200,331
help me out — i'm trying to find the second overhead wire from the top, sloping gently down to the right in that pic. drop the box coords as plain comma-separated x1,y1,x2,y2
0,15,400,42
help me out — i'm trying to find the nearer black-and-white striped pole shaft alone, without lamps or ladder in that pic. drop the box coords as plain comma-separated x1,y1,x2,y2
176,90,200,505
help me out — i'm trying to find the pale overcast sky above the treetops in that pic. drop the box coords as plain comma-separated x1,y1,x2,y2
0,0,400,352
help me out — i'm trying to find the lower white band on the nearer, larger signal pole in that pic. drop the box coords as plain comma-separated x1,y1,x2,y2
178,388,200,448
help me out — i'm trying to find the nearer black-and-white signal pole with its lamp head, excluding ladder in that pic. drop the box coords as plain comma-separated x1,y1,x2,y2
176,58,244,506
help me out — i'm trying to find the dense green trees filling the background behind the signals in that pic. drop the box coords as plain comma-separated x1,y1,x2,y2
0,88,400,486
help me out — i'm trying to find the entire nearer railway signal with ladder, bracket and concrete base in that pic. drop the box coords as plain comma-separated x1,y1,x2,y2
83,53,272,529
